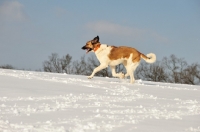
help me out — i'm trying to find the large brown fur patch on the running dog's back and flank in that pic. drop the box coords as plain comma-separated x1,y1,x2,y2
108,46,141,62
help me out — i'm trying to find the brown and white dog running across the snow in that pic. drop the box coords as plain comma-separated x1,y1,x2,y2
82,36,156,83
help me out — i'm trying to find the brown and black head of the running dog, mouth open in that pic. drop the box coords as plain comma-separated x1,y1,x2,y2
82,36,100,53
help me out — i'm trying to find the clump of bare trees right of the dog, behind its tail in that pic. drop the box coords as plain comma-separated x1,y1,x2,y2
136,55,200,85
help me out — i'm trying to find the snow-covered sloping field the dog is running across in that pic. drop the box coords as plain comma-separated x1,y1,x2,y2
0,69,200,132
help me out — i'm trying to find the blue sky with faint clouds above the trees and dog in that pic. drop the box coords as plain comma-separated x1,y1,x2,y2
0,0,200,70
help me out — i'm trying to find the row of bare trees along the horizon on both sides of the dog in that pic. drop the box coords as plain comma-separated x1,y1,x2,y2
43,53,200,85
